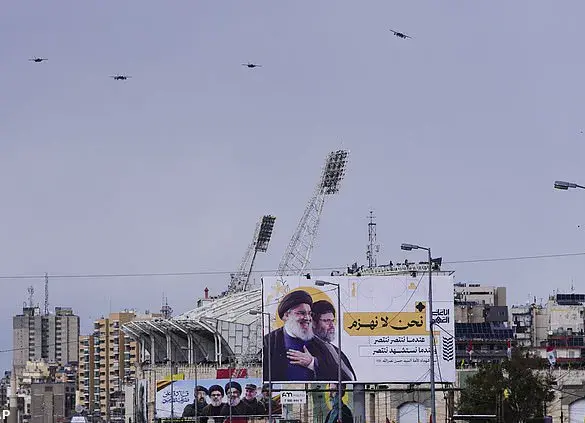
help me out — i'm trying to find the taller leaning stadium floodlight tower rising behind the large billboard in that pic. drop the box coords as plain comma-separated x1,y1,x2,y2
276,150,349,277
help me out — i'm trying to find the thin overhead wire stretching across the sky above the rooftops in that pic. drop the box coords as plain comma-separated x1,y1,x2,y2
0,252,585,280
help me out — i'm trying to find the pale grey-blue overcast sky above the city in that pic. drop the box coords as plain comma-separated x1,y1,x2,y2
0,0,585,369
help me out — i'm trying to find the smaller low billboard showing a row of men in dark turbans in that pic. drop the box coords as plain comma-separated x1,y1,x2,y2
156,378,281,419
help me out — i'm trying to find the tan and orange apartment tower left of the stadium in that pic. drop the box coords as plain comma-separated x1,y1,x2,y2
78,311,162,422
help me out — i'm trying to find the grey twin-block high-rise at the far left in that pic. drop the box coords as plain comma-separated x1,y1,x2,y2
12,307,79,375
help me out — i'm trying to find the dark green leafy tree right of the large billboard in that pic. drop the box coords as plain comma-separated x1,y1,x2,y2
457,350,555,423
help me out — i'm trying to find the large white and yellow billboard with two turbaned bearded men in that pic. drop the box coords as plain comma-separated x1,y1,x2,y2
262,272,455,383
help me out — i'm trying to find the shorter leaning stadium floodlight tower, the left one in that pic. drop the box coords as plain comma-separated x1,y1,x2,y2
228,215,276,293
